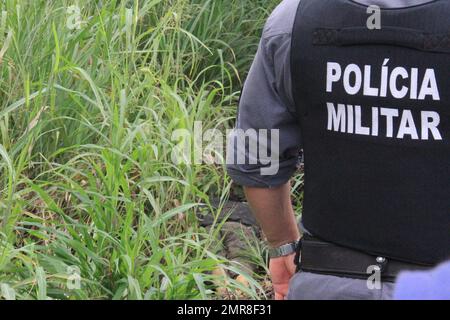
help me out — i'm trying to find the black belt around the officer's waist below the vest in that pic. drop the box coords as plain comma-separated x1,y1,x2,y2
296,235,432,282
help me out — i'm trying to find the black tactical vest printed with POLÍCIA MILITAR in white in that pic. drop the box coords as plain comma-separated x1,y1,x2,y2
291,0,450,264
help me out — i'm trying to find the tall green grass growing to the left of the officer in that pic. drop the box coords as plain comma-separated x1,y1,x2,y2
0,0,278,299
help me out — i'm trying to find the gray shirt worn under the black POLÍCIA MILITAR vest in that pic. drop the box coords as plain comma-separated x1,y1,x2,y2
227,0,438,188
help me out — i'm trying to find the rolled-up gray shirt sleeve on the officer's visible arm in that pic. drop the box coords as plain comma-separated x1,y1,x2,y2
227,0,301,188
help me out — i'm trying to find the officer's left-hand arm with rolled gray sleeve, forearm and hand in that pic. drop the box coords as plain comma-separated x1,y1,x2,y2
227,0,301,300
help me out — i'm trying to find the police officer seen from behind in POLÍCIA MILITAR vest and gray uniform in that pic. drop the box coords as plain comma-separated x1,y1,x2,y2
228,0,450,299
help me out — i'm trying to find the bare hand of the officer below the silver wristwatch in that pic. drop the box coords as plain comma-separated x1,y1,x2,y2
269,253,296,300
